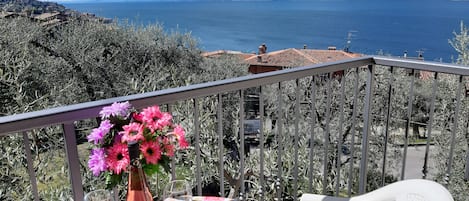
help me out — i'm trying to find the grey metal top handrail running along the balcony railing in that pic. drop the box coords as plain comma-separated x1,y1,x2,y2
0,56,469,136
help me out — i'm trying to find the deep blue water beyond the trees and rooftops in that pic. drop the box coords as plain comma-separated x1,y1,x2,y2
65,0,469,62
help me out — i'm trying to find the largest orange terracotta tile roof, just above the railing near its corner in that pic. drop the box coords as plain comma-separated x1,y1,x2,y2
245,48,361,67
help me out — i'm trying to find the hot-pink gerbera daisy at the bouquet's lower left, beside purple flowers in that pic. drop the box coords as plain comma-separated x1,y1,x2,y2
106,143,130,174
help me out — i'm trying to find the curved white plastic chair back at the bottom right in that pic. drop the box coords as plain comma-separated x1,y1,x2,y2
300,179,454,201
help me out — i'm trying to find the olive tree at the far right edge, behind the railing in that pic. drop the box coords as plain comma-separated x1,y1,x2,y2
434,22,469,201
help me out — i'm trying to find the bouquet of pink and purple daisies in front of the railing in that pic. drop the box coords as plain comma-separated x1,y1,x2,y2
87,102,189,189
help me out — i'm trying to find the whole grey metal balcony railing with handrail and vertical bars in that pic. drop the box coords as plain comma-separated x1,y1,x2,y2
0,56,469,200
